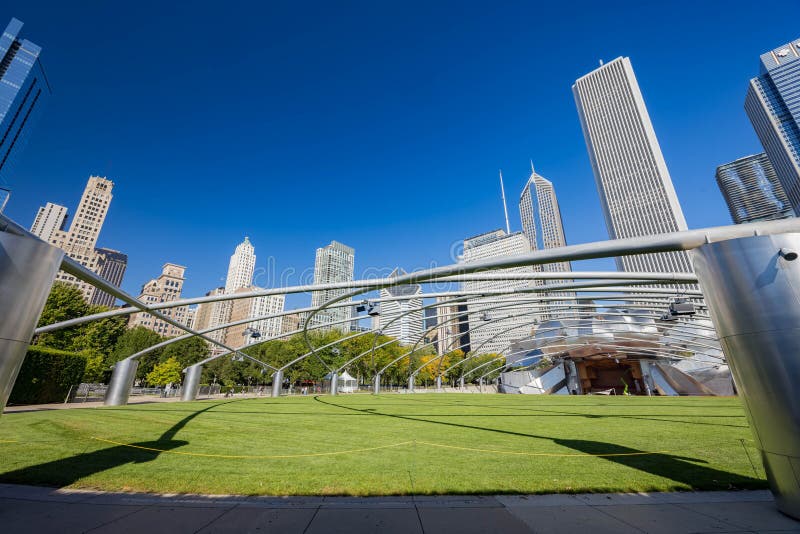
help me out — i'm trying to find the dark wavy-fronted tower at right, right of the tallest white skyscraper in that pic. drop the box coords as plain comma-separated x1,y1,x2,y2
717,152,794,224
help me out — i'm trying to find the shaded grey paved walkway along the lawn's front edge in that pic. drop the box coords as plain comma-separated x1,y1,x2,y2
0,484,800,534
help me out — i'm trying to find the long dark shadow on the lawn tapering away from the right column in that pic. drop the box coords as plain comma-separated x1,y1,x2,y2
314,396,766,491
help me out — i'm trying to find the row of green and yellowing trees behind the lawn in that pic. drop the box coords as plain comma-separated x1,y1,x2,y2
34,282,503,386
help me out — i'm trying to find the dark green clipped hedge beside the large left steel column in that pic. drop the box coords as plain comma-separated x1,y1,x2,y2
8,345,86,404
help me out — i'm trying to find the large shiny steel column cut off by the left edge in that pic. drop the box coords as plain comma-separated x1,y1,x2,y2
0,232,64,413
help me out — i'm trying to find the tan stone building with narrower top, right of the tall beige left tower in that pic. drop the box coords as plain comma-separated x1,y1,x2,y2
128,263,188,337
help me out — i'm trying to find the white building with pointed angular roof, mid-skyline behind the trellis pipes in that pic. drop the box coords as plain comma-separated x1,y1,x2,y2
380,267,425,345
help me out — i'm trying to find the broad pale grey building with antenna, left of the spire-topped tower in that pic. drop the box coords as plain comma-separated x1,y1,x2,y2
461,230,539,353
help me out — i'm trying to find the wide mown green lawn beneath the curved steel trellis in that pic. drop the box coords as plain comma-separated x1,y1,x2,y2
0,394,767,495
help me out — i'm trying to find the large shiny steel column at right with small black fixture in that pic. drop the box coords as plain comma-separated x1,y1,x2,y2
693,233,800,519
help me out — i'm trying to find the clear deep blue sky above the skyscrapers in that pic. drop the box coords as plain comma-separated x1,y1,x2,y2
0,0,800,304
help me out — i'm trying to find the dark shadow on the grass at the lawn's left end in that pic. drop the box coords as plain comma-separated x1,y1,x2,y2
0,401,237,487
